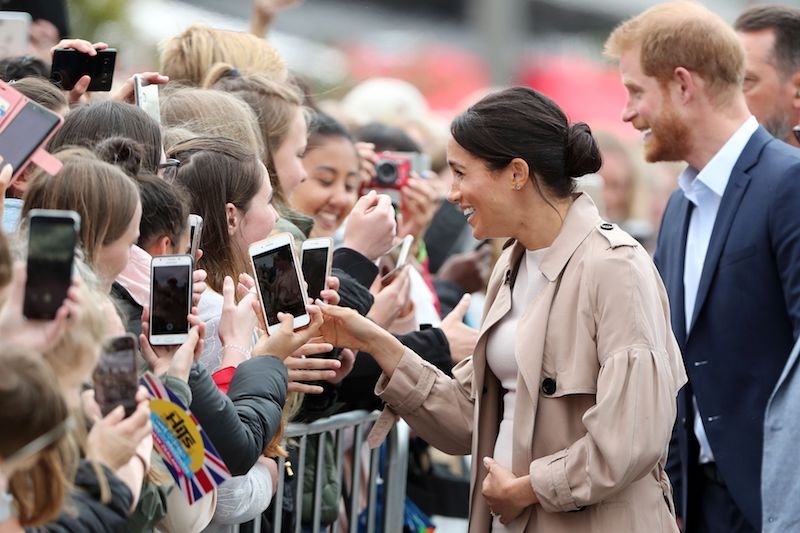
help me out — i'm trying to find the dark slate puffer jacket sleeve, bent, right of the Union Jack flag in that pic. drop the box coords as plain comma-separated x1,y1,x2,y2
189,357,289,476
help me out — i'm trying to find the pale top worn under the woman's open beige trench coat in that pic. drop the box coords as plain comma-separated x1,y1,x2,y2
486,248,548,532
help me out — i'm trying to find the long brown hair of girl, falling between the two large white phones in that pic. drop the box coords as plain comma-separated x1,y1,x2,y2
168,137,266,294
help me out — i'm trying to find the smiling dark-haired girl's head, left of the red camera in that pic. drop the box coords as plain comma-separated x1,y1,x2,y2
289,113,361,237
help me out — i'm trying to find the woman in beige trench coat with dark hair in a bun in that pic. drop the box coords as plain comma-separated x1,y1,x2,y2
323,88,686,533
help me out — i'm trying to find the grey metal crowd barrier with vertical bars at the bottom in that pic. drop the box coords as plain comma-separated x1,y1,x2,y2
230,411,409,533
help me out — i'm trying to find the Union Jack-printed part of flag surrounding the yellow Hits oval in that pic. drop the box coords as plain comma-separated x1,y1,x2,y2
141,372,231,505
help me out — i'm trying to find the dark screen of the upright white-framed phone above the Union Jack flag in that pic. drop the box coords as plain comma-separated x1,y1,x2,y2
150,265,192,336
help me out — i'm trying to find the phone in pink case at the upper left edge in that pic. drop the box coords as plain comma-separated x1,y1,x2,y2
0,82,63,182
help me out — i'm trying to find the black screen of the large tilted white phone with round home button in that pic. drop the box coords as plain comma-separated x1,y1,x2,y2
253,244,306,326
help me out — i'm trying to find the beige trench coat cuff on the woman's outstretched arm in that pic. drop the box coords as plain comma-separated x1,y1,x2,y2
375,349,436,416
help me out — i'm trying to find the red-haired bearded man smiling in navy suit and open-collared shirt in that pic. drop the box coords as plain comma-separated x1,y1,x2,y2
606,2,800,533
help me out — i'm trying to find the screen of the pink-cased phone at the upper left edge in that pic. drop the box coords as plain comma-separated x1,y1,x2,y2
0,102,59,172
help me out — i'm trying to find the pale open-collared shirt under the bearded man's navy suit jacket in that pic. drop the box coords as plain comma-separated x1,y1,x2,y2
678,115,758,464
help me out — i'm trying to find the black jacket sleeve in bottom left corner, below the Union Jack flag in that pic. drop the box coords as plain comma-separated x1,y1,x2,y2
25,459,133,533
